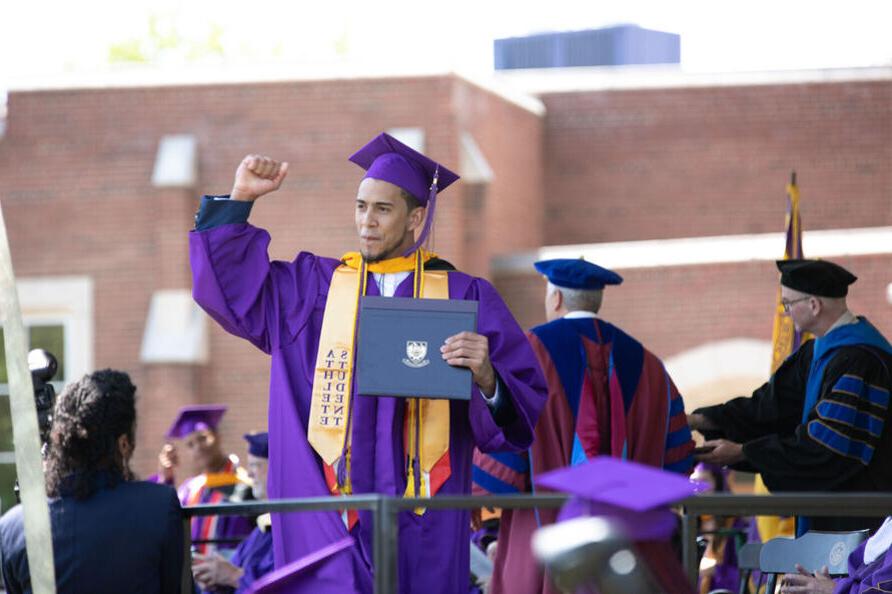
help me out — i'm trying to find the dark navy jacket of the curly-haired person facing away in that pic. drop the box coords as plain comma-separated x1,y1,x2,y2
0,481,183,594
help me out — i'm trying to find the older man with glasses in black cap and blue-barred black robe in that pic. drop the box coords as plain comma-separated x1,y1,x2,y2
688,260,892,534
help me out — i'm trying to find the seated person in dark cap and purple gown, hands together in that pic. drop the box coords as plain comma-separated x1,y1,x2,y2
192,432,274,594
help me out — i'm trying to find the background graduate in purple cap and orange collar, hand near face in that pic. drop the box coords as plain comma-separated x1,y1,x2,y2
159,404,252,554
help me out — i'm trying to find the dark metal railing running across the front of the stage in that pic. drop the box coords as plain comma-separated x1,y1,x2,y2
183,493,892,594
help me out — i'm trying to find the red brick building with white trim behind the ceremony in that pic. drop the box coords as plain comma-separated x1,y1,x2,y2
0,63,892,505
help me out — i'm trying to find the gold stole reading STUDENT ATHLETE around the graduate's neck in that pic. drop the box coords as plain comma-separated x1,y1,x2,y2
307,250,451,527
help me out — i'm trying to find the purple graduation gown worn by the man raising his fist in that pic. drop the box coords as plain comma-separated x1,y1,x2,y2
189,223,547,594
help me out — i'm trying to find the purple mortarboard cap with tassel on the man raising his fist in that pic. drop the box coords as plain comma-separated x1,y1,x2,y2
350,132,459,253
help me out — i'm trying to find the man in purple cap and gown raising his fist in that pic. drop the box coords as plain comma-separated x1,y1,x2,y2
189,134,546,594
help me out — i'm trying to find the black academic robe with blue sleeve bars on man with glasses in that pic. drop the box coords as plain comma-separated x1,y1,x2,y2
694,341,892,530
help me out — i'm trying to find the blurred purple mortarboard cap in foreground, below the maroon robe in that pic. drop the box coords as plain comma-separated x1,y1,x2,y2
536,456,700,540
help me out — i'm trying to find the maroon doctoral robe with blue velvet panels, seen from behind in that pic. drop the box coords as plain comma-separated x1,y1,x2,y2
474,318,694,594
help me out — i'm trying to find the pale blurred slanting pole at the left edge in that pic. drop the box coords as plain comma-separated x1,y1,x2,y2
0,201,56,594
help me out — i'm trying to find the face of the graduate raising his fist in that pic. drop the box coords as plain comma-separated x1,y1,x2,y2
354,177,424,262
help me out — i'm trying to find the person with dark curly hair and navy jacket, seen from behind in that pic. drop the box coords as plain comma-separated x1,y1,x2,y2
0,369,183,594
